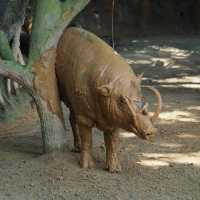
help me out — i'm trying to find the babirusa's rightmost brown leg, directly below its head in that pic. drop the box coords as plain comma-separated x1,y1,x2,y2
104,133,121,172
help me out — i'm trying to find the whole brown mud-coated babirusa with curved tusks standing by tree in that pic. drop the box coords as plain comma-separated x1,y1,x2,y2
56,28,161,172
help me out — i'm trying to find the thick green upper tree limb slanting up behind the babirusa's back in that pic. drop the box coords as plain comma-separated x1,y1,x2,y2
28,0,90,66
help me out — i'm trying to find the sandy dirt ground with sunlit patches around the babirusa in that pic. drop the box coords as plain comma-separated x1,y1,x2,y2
0,37,200,200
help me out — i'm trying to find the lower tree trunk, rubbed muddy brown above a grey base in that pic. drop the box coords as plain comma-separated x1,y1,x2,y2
33,49,66,152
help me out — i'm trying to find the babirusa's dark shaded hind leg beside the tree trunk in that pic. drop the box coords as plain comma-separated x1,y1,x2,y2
69,111,81,153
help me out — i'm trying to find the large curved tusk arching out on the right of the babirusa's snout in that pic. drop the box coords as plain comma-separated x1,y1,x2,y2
142,86,162,122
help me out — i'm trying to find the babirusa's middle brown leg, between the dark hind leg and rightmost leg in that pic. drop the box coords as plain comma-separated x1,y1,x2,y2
79,125,94,168
